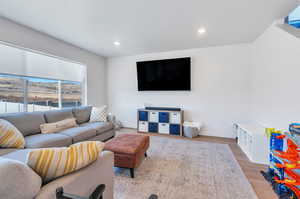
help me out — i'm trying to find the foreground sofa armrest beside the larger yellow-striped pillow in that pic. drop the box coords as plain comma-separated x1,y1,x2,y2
36,151,114,199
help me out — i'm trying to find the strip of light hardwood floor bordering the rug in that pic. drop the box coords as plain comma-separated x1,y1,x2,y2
119,128,278,199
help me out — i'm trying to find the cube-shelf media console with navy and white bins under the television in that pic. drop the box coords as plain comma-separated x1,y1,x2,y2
137,107,183,136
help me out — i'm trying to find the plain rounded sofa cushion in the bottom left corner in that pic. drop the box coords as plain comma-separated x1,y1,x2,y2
0,158,42,199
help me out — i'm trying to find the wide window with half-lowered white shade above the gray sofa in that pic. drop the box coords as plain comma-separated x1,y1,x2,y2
0,43,86,113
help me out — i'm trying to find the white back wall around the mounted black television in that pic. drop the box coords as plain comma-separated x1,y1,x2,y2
108,44,250,137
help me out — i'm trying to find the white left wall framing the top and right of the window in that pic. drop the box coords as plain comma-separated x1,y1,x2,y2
0,17,107,106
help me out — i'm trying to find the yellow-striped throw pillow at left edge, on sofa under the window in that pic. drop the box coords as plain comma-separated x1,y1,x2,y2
0,119,25,149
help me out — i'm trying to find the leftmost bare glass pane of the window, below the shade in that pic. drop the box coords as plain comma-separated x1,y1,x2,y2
0,74,25,113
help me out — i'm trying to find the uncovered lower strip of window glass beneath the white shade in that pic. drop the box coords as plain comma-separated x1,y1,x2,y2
0,74,82,113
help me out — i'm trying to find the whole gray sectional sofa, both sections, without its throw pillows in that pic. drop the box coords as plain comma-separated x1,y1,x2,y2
0,106,115,199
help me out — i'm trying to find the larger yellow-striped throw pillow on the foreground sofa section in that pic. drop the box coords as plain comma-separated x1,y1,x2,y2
26,141,104,182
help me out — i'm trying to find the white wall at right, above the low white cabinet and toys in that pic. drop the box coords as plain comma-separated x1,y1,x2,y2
251,25,300,129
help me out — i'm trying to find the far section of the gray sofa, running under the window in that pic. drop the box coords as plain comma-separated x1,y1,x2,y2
0,106,115,155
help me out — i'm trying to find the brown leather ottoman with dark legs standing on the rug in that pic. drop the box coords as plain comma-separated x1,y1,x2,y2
104,134,150,178
